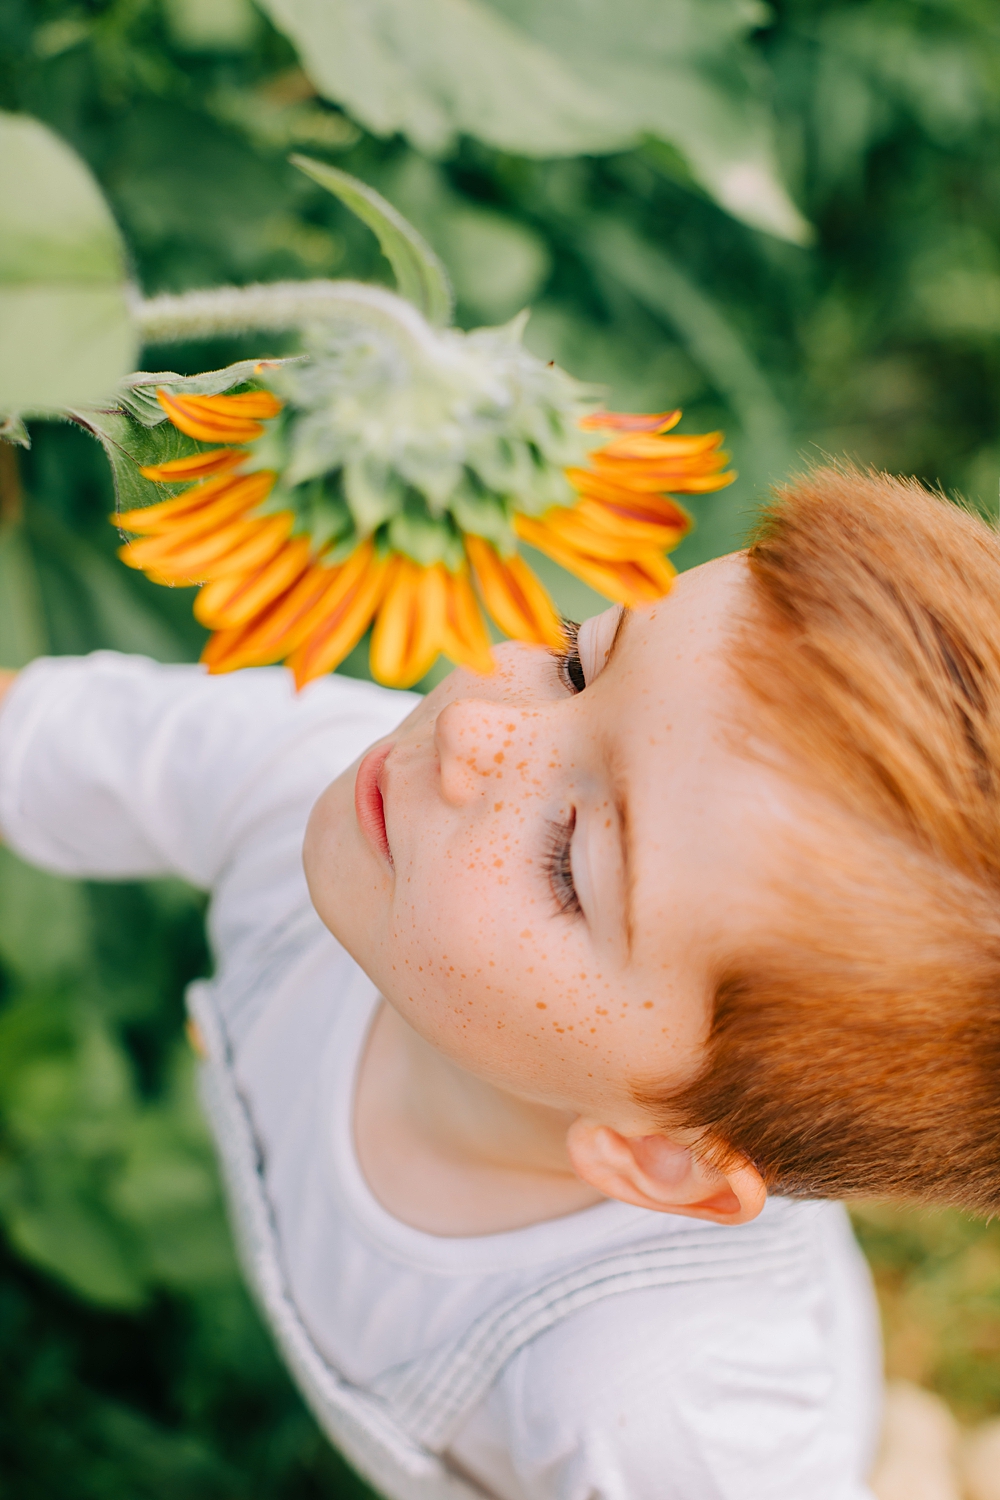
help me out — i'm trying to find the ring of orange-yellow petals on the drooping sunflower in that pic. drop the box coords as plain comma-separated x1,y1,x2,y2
114,389,735,687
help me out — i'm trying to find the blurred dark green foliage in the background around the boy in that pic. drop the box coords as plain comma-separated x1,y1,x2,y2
0,0,1000,1482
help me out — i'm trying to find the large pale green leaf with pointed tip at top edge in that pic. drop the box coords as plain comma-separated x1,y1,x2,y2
254,0,811,243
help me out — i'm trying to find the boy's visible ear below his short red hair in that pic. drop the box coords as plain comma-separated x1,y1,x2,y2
567,1118,768,1224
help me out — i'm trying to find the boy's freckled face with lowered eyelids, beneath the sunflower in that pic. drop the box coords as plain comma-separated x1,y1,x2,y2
304,555,802,1136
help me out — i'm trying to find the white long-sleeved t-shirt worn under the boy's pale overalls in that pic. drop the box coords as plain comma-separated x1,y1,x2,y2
0,653,880,1500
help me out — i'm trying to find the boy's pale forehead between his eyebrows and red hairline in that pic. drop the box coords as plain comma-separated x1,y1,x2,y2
594,554,804,969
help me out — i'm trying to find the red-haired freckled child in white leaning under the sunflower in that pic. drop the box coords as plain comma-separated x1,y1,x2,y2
0,470,1000,1500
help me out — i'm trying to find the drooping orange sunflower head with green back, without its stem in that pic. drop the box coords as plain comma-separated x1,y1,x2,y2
115,288,735,687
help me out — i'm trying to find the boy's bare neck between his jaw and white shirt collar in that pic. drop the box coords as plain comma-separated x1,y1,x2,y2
355,1005,601,1235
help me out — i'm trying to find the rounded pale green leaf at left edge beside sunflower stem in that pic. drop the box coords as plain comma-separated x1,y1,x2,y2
0,111,136,414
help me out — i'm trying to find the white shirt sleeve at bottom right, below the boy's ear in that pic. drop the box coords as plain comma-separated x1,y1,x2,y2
450,1248,880,1500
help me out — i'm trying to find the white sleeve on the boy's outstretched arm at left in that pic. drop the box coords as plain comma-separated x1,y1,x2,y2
0,651,414,890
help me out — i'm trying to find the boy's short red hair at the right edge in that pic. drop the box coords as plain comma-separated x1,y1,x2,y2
653,468,1000,1212
